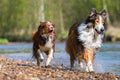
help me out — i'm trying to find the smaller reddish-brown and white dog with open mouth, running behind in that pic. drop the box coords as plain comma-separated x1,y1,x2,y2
32,22,55,67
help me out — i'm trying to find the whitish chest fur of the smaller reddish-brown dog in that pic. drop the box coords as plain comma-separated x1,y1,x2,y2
39,37,53,51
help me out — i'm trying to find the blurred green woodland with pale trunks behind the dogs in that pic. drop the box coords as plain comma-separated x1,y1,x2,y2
0,0,120,41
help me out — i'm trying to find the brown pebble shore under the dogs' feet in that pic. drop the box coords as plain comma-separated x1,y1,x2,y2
0,56,120,80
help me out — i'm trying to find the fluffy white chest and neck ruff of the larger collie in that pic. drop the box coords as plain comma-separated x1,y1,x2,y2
78,23,103,49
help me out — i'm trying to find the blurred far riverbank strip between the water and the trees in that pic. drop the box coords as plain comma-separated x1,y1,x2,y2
0,26,120,44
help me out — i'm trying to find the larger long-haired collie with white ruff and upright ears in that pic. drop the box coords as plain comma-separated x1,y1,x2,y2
66,8,107,72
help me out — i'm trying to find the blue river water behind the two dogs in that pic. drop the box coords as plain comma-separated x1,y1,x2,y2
0,43,120,74
